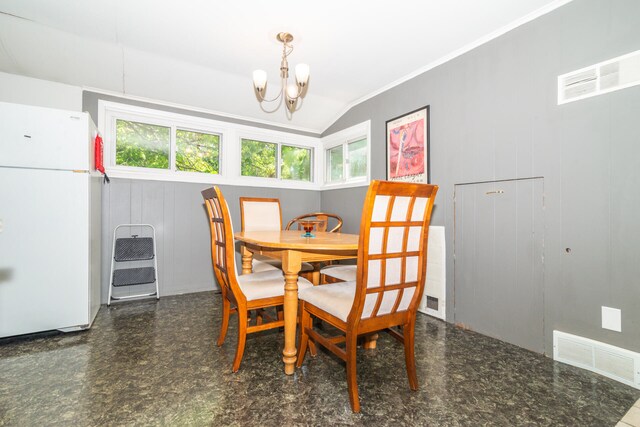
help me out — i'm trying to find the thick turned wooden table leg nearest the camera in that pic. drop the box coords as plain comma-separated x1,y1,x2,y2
282,251,302,375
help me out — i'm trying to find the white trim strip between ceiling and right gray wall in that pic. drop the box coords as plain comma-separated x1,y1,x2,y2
323,0,573,132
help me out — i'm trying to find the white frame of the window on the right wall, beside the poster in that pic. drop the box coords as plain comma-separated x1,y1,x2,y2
322,120,371,190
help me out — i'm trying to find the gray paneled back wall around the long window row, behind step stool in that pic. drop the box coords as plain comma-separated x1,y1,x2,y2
82,91,320,303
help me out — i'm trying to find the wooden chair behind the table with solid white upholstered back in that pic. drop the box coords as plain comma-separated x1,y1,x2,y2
240,197,313,273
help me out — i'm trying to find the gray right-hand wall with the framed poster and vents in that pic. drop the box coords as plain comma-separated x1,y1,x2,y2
322,0,640,351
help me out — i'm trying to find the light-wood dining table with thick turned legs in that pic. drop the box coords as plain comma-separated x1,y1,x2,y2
234,230,359,375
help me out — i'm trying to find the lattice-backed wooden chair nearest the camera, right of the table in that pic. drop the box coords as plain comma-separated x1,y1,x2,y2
297,181,438,412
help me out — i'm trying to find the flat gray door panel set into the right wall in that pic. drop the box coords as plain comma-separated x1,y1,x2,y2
454,178,544,353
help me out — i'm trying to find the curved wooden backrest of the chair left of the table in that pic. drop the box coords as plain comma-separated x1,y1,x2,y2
202,187,246,304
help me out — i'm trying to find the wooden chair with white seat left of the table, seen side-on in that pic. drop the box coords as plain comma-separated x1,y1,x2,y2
202,187,312,372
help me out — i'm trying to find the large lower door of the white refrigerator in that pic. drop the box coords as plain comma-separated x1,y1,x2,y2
0,167,89,337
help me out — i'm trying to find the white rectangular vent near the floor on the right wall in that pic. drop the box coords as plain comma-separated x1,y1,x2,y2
553,331,640,389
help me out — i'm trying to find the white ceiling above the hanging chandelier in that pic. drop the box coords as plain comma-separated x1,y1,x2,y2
0,0,567,132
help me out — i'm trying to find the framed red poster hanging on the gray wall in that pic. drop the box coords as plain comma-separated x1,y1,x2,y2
386,105,431,183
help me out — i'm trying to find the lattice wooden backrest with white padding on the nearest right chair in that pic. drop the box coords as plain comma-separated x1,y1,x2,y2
348,181,438,323
